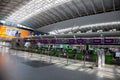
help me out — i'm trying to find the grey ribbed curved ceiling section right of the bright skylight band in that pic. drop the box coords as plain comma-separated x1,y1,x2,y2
19,0,120,29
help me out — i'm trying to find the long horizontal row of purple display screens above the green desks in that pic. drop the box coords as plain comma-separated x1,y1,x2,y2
25,38,120,44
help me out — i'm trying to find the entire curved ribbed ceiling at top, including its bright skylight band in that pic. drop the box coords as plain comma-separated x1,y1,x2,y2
0,0,120,29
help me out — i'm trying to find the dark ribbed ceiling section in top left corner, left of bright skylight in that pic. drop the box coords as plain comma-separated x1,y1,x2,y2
0,0,30,20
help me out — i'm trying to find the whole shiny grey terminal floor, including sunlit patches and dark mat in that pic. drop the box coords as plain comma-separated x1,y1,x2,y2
0,47,120,80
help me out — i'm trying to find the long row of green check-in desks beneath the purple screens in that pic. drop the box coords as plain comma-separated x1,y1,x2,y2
10,47,120,65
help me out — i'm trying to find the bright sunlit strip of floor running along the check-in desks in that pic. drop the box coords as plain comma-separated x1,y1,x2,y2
6,48,120,79
